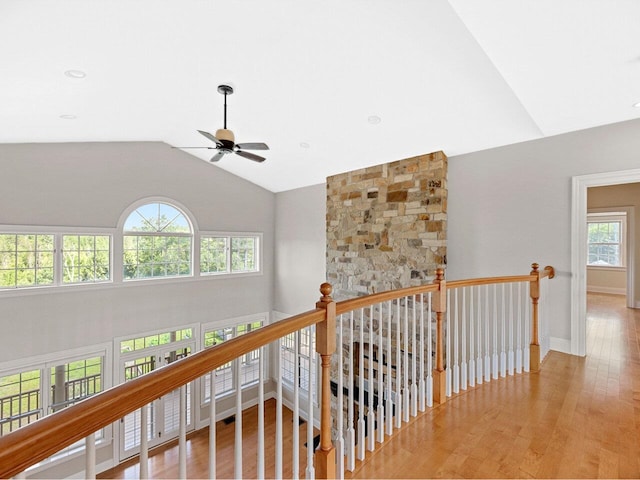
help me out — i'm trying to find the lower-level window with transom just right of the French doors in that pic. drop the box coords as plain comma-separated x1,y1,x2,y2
203,320,263,402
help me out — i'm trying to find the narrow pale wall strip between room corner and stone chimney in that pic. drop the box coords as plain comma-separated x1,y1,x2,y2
274,184,327,314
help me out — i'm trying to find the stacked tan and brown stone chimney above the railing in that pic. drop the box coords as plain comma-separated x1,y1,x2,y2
327,152,447,300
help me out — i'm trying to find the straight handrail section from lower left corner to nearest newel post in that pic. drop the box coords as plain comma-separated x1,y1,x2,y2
0,308,325,478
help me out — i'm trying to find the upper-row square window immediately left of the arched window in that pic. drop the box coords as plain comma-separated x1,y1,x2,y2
62,235,111,284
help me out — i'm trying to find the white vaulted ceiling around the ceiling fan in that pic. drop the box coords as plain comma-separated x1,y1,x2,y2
0,0,640,192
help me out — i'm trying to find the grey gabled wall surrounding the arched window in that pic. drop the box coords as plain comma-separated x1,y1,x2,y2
0,142,275,363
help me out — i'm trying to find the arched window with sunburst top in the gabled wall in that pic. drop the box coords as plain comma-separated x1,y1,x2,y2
122,202,193,280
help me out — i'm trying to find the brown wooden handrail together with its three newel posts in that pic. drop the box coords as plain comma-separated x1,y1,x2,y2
0,263,555,478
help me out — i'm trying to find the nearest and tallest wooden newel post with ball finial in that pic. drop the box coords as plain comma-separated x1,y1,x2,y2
314,283,336,478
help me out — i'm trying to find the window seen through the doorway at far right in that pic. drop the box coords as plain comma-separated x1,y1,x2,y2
587,212,627,267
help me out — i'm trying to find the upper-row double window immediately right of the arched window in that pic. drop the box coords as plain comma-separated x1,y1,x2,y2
200,235,259,274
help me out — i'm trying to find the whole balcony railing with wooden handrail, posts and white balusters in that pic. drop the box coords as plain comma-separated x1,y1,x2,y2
0,264,554,478
